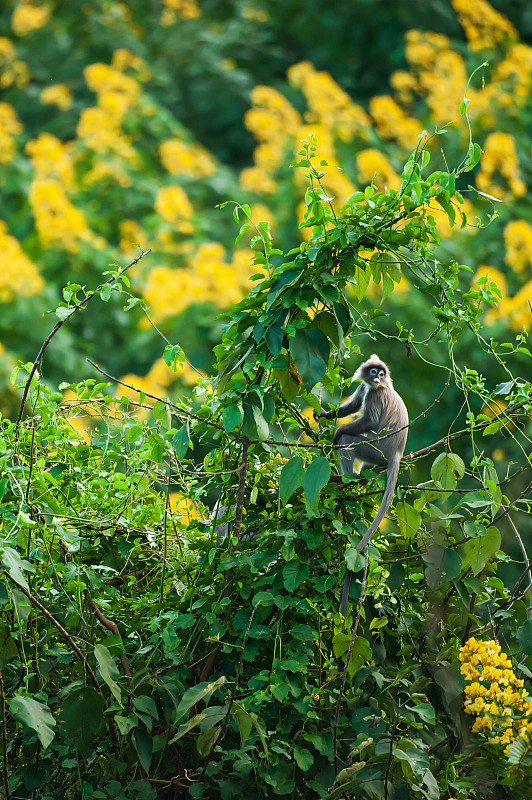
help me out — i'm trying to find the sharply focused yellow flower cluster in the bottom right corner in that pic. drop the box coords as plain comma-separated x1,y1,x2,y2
459,638,532,749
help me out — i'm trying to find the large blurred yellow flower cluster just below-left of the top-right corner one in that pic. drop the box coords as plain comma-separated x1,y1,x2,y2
404,30,467,122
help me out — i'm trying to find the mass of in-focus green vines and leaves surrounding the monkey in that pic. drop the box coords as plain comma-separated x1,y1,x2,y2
0,120,531,800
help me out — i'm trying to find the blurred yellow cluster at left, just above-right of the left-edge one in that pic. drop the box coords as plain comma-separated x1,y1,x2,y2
29,178,105,253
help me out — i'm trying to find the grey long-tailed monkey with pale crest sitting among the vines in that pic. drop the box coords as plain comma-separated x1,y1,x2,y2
320,354,408,616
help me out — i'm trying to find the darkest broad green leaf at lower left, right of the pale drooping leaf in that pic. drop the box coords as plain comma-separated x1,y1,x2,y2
60,686,104,755
